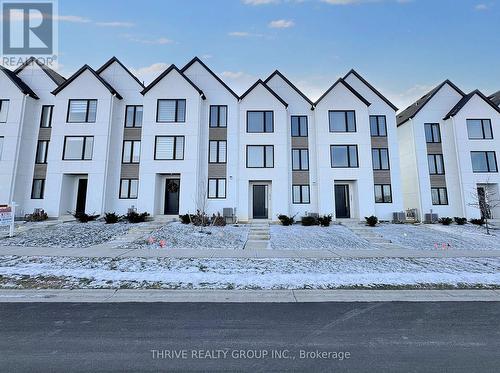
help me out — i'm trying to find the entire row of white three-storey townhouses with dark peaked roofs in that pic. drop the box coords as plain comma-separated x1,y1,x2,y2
0,57,500,221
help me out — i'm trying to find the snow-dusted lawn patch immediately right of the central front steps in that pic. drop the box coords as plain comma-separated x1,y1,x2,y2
270,225,373,250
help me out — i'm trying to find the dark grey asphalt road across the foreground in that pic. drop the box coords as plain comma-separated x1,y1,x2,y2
0,302,500,373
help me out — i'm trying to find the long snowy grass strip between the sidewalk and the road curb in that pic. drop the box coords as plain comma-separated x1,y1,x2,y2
0,256,500,289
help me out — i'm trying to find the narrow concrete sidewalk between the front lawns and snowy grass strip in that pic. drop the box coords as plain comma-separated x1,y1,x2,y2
0,245,500,259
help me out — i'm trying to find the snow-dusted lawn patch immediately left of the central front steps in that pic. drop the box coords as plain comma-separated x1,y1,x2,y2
125,222,249,249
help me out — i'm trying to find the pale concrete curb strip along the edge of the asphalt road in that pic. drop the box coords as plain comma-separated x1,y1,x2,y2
0,289,500,303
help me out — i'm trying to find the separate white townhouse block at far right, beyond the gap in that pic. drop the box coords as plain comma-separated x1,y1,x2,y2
397,80,500,220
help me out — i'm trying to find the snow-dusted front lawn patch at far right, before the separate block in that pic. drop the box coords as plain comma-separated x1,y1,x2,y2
374,224,500,250
